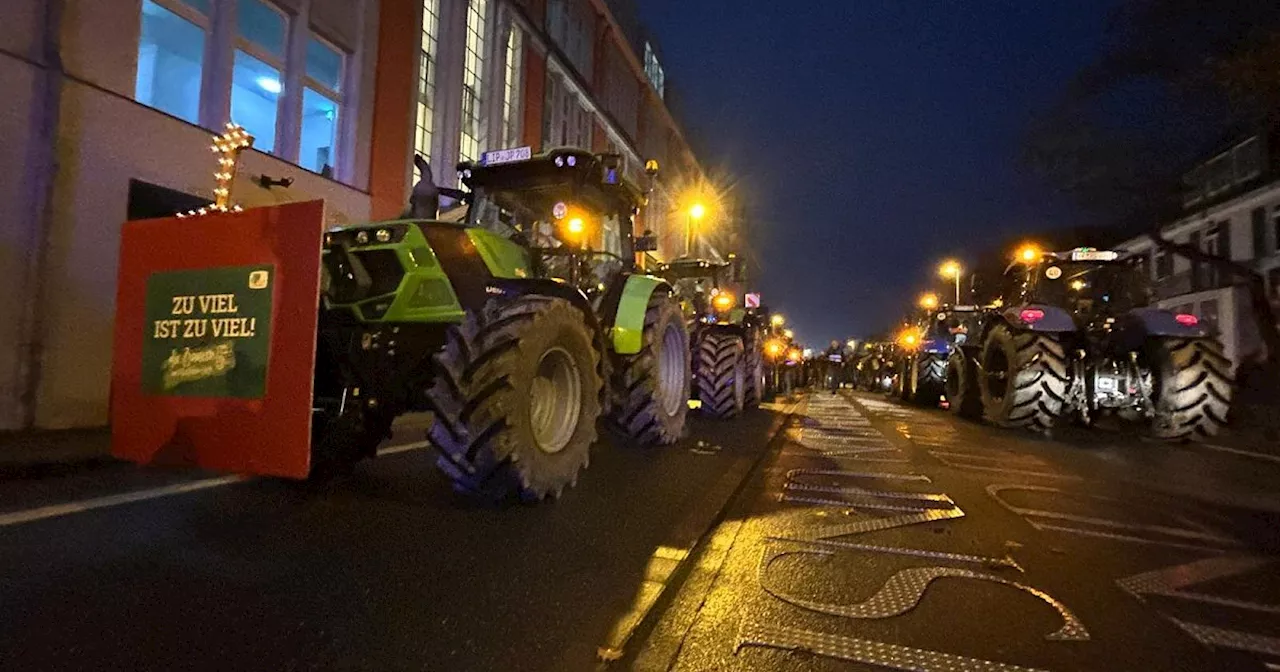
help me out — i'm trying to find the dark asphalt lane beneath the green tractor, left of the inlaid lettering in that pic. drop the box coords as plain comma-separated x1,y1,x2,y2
0,410,783,671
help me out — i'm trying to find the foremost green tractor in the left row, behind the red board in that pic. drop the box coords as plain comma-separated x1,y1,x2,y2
312,148,691,500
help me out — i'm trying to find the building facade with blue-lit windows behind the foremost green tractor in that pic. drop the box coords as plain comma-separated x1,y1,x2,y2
0,0,700,430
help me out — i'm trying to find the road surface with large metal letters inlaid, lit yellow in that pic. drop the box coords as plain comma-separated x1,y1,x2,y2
623,393,1280,672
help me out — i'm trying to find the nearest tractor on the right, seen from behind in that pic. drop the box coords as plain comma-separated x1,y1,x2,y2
946,247,1233,440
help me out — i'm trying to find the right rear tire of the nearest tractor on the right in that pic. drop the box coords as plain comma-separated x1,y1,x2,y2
1148,338,1233,440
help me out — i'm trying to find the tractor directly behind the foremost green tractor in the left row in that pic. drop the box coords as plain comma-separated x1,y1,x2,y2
658,255,769,420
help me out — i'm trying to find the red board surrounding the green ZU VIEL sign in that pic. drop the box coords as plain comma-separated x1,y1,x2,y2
110,201,324,479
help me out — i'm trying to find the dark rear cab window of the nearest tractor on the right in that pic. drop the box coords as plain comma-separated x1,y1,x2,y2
1034,261,1149,316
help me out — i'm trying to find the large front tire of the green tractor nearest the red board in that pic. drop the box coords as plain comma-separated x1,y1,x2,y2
426,296,602,500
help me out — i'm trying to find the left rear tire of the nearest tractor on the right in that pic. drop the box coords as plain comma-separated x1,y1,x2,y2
978,324,1070,431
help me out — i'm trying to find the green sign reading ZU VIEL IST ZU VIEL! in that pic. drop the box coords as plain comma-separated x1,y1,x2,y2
142,265,275,399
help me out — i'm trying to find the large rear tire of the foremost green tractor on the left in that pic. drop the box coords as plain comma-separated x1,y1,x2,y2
609,292,692,447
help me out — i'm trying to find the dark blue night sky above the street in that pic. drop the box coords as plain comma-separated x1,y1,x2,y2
639,0,1115,346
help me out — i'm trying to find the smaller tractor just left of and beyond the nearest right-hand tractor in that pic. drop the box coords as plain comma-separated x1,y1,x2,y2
895,303,984,407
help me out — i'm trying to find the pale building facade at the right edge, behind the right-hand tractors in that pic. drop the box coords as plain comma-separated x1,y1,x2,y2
1120,134,1280,366
